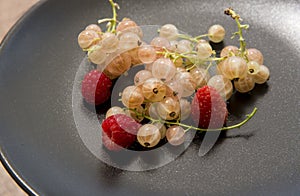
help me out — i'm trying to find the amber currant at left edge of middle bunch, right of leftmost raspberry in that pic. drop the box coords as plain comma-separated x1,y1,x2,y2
122,86,144,108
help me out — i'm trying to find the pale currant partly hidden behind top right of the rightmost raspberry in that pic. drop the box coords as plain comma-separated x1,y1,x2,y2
207,75,233,100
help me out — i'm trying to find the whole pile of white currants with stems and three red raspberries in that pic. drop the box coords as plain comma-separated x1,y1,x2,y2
78,0,269,150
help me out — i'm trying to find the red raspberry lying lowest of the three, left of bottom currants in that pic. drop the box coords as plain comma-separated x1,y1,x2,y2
102,114,141,151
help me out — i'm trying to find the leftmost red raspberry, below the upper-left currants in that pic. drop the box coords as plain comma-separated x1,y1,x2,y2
81,70,112,105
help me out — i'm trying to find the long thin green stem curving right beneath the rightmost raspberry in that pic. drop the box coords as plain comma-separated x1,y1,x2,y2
126,107,257,132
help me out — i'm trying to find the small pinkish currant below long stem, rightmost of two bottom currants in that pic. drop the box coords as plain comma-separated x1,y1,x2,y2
166,125,185,146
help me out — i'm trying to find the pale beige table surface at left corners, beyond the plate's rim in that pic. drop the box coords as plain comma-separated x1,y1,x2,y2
0,0,38,196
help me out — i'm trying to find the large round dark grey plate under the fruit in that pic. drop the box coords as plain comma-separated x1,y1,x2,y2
0,0,300,195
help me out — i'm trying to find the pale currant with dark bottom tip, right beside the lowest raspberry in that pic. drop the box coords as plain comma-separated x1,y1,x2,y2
137,124,161,148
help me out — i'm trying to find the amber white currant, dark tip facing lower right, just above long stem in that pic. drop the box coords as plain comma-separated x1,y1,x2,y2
156,97,180,120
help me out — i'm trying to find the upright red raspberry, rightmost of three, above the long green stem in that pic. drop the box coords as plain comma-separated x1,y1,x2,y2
191,86,228,129
